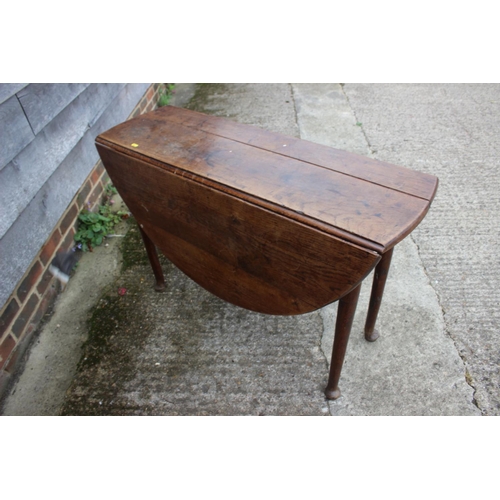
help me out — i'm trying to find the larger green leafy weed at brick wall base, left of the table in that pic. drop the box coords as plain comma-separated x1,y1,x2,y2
74,196,128,252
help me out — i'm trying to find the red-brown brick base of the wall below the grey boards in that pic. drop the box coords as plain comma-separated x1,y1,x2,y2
0,84,162,395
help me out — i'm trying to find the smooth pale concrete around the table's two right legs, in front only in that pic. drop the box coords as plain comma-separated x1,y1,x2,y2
322,238,480,416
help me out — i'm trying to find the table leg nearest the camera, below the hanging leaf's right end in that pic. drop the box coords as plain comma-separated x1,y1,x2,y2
325,284,361,399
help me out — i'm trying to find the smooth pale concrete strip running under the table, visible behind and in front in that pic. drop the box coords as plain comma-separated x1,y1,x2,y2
293,84,480,415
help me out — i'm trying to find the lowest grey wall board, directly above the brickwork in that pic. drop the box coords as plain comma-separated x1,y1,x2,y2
0,84,149,307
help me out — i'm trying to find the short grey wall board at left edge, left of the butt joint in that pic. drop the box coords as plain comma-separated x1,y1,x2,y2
0,95,35,170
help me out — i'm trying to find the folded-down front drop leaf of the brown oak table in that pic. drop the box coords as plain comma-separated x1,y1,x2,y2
98,145,380,314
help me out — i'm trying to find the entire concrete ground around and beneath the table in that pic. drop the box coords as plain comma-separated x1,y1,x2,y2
2,84,500,416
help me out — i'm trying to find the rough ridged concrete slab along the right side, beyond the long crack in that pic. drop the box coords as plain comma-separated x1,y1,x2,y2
344,84,500,415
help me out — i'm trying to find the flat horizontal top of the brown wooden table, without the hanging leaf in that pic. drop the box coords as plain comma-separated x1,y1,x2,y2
99,106,438,252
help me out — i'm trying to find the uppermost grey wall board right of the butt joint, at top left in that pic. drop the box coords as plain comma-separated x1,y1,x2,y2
17,83,90,134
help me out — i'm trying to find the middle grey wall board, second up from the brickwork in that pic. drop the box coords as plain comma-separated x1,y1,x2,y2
0,83,125,238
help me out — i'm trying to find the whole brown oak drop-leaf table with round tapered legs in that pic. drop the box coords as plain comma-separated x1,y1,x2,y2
96,106,438,399
